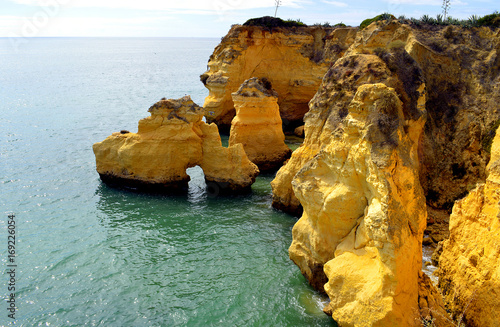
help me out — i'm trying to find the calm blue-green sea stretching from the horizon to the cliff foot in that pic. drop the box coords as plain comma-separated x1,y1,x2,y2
0,38,334,326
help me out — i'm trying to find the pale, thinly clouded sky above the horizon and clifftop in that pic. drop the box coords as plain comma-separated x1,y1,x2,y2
0,0,500,37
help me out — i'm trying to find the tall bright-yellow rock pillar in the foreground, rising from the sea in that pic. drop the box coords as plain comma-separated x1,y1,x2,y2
289,83,426,326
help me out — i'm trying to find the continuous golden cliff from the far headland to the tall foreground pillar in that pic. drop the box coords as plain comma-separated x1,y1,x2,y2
195,20,500,326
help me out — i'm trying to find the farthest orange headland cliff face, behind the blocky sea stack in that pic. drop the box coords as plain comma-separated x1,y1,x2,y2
201,25,356,131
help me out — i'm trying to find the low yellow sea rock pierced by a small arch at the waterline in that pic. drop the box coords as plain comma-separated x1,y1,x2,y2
93,96,259,192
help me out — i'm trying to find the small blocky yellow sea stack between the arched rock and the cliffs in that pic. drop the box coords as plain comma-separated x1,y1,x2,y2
229,77,292,171
